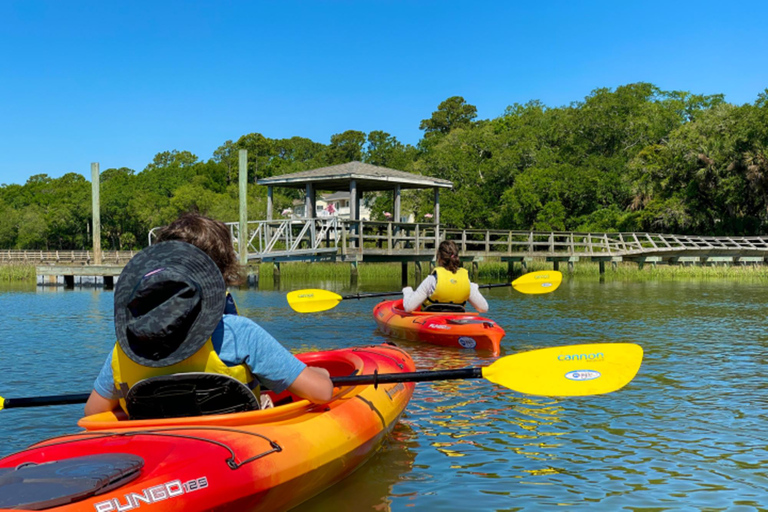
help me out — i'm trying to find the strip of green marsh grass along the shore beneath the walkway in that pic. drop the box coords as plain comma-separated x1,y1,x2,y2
0,260,768,284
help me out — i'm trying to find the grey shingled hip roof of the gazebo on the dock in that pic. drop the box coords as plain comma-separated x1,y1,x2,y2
256,162,453,191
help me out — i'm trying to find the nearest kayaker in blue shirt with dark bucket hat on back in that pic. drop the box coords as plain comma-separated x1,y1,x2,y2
85,214,333,418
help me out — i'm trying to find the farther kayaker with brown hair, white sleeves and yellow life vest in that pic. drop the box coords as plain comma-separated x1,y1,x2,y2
403,240,488,313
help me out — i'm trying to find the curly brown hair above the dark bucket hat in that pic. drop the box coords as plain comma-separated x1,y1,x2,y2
157,213,243,285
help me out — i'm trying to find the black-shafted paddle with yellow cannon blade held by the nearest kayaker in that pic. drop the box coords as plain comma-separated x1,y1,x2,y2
0,343,643,410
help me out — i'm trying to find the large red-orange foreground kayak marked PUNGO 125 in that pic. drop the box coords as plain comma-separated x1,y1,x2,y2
0,344,414,512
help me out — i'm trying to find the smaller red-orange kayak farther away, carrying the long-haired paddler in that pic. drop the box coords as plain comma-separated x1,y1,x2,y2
373,299,505,356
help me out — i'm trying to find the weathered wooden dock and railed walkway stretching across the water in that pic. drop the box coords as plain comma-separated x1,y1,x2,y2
21,221,768,288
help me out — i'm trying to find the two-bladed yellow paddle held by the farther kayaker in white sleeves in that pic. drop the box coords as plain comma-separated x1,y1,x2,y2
286,270,563,313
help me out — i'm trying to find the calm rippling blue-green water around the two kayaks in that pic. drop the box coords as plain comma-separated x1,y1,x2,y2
0,278,768,512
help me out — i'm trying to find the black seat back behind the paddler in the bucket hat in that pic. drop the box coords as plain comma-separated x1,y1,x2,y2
125,373,259,420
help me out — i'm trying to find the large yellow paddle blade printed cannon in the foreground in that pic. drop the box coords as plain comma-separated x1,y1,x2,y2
483,343,643,396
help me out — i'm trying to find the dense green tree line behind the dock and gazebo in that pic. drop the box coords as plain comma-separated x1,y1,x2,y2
0,83,768,250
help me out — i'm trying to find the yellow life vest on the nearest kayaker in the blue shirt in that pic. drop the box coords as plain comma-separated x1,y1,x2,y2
112,338,255,412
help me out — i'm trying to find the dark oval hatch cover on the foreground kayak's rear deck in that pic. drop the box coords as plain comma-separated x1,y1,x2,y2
0,453,144,510
